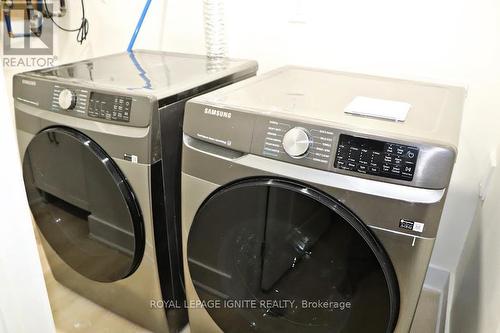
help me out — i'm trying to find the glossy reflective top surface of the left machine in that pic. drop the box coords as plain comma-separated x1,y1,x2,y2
19,50,257,99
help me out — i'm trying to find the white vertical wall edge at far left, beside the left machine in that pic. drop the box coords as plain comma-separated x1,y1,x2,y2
0,68,54,333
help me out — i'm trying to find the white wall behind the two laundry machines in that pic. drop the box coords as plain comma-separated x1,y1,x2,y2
6,0,500,330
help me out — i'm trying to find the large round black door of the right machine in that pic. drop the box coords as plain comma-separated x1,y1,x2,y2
187,178,399,333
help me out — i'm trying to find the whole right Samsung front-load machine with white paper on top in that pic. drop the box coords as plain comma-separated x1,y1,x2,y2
182,67,465,333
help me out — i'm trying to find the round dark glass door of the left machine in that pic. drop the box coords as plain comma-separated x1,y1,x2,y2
23,127,145,282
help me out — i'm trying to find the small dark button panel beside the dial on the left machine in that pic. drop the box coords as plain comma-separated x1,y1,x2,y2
87,92,132,122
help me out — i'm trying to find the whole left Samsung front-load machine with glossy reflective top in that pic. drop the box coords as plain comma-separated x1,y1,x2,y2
14,51,256,332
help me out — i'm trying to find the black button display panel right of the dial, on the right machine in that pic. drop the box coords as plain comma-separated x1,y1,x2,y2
334,134,419,181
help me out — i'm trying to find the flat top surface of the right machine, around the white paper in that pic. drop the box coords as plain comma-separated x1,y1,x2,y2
192,66,466,147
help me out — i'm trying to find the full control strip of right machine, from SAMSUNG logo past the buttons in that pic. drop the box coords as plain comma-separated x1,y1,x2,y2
183,99,456,189
